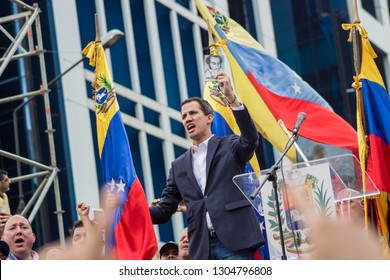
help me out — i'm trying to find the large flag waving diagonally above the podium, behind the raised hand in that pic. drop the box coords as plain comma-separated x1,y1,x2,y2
195,0,358,159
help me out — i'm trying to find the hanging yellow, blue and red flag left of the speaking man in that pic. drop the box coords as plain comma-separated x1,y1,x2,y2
83,41,157,260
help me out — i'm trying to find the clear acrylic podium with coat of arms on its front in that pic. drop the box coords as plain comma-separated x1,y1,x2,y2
233,154,379,259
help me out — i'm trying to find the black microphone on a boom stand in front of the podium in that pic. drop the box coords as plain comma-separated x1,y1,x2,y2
250,130,298,260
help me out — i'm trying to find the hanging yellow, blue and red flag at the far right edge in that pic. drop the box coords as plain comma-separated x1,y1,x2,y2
342,24,390,253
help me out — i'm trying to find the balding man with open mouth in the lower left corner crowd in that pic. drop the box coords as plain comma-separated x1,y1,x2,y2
2,215,39,260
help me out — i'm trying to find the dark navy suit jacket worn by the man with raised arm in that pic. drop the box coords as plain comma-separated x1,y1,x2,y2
150,106,264,259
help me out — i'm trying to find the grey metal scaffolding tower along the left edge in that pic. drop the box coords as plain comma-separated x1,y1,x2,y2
0,0,65,246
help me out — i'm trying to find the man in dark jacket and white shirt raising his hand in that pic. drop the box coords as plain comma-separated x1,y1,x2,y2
150,73,264,260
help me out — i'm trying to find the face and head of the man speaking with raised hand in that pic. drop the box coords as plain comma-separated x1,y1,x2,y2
181,101,214,145
